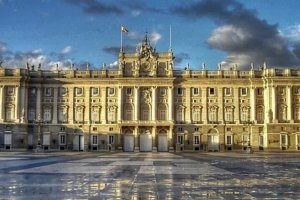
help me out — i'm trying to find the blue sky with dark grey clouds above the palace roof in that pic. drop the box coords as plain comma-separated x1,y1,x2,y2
0,0,300,70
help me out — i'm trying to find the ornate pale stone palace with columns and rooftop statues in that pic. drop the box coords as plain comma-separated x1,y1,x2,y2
0,37,300,151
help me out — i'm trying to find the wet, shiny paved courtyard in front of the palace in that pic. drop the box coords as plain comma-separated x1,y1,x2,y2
0,152,300,200
